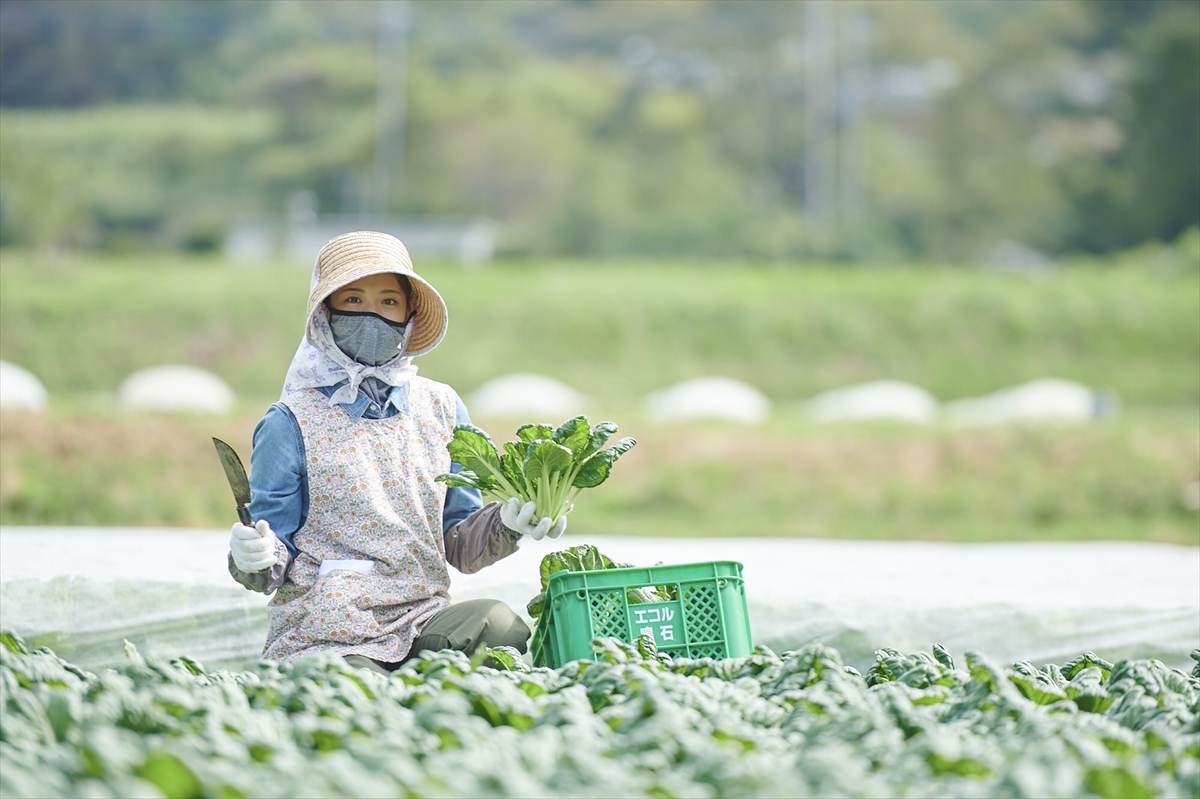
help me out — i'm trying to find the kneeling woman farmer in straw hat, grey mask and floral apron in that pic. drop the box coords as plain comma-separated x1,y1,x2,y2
229,232,566,672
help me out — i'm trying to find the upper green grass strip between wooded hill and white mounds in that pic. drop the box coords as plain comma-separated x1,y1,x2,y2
0,252,1200,410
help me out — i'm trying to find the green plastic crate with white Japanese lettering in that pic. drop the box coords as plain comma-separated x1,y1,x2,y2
530,560,754,668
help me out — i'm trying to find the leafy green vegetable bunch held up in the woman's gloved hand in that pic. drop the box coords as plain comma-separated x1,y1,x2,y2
437,416,637,518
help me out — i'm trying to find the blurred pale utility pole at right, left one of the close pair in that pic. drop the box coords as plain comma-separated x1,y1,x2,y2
804,0,838,228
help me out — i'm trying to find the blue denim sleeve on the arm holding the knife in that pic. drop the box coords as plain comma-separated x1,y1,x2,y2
250,403,308,558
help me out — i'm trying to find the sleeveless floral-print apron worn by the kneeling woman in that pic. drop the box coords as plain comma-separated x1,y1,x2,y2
263,377,456,662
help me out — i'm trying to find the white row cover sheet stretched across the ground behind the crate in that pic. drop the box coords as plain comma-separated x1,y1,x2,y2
0,527,1200,671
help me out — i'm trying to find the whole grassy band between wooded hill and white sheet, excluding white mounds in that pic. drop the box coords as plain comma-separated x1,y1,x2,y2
0,252,1200,543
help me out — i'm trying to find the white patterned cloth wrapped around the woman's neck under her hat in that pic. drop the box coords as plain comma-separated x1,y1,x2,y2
281,266,416,405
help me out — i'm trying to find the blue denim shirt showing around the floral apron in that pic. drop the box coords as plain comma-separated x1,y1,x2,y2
250,380,484,558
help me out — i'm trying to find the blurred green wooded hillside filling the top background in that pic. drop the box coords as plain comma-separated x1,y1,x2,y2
0,0,1200,263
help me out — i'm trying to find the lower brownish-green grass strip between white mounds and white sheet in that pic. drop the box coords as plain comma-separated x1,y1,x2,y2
0,405,1200,545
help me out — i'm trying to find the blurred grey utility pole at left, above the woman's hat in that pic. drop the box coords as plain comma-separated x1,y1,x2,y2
371,0,409,215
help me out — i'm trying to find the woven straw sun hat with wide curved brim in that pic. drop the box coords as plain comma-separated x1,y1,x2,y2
305,230,449,355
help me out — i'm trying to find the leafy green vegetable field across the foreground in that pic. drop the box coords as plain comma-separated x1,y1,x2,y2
0,635,1200,798
